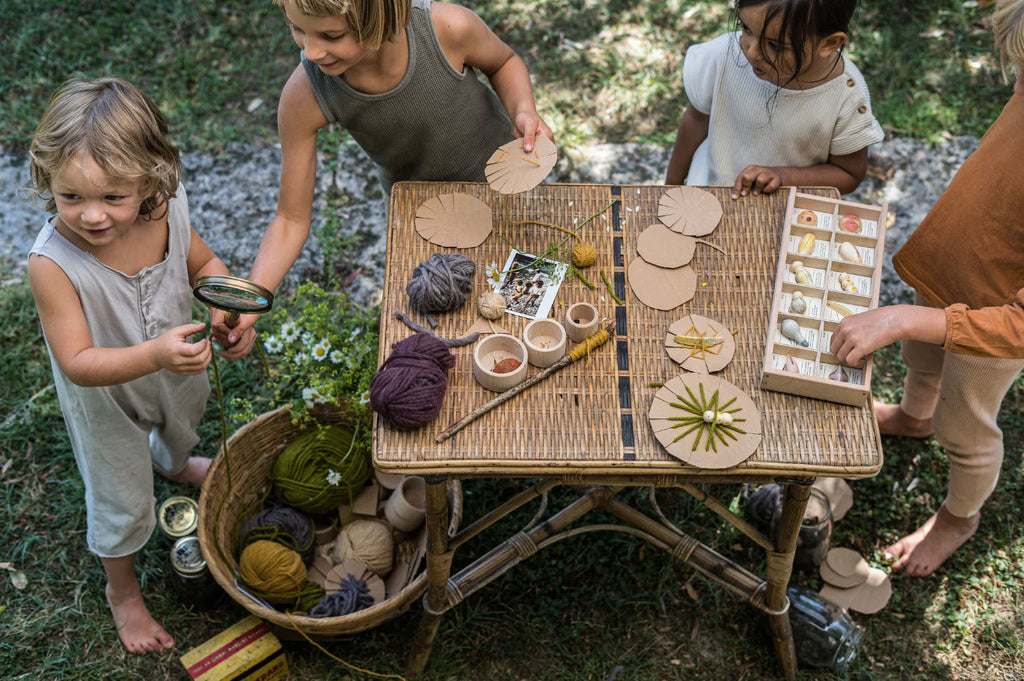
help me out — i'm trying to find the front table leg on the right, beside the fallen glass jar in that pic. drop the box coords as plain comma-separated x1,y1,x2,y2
765,481,811,679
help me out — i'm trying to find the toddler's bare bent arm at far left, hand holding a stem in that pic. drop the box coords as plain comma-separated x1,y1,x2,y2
29,255,212,387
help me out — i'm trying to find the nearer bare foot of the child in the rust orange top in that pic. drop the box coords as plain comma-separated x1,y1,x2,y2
885,506,981,577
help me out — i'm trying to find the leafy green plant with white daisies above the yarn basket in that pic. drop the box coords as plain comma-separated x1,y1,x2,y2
231,283,380,422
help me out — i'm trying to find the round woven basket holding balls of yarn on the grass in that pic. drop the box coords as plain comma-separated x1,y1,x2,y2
199,407,462,639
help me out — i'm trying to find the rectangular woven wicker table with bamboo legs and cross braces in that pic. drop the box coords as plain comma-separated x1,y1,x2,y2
374,182,882,678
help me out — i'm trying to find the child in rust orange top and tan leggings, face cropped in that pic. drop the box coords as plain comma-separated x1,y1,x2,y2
831,0,1024,577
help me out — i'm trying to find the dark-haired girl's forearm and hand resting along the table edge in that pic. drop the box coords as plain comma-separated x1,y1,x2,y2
732,146,867,199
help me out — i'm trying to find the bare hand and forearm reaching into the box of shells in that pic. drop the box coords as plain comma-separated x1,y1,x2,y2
829,305,946,367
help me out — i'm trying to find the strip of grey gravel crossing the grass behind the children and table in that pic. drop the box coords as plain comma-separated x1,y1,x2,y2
0,137,977,303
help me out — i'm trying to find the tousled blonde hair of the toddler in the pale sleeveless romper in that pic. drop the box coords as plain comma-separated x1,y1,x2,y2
29,78,181,218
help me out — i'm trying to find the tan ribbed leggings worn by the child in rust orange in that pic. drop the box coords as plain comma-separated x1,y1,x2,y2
900,296,1024,518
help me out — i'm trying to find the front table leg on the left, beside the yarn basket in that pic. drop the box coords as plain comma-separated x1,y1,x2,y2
406,475,452,680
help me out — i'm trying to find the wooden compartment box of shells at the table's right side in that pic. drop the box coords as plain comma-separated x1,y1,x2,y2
761,189,887,406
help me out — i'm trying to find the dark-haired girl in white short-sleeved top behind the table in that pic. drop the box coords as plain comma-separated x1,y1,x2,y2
666,0,885,199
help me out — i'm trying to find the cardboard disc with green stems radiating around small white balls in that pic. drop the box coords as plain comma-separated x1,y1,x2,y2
647,374,761,468
